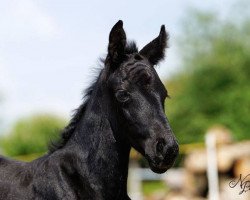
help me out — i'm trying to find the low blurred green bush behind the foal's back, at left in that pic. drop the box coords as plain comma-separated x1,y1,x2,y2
0,115,65,156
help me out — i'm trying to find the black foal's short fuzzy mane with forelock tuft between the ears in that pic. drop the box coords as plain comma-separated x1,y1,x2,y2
48,41,138,154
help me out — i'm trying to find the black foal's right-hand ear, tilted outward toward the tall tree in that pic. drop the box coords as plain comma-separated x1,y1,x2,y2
140,25,168,65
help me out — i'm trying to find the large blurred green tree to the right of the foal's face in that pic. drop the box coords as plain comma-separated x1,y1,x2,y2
166,12,250,143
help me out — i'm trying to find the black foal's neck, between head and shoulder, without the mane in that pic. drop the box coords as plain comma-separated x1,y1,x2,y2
65,78,130,196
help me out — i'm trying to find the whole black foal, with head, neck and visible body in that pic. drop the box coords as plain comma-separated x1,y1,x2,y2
0,21,178,200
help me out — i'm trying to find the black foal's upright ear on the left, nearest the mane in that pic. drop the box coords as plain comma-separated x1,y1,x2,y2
107,20,126,64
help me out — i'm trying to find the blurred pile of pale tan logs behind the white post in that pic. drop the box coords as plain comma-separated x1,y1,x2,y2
165,128,250,200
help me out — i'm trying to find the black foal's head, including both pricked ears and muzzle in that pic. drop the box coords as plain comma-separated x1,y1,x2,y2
105,21,178,173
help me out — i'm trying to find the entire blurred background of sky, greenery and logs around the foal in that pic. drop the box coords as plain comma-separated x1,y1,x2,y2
0,0,250,200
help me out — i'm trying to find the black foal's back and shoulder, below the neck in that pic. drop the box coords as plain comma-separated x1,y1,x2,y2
0,152,93,200
